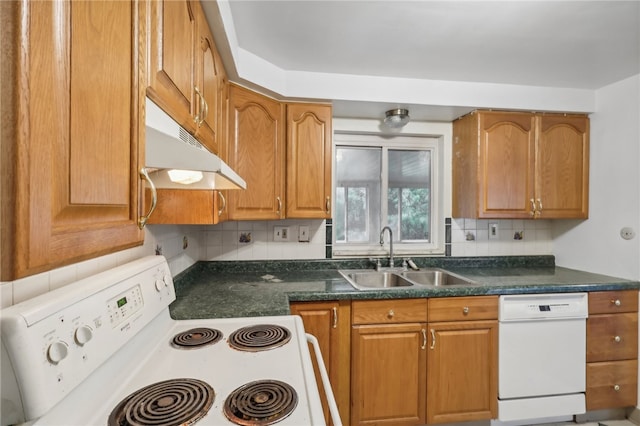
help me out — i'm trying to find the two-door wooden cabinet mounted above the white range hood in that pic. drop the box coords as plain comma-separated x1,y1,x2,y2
147,0,224,154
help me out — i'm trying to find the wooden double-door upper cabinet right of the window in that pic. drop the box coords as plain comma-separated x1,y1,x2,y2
453,111,589,219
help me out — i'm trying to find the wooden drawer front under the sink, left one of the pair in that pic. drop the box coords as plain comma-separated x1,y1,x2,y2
351,299,427,325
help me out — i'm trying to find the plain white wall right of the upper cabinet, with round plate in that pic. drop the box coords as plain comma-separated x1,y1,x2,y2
552,74,640,280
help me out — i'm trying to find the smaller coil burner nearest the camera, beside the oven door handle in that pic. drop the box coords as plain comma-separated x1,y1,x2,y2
224,380,298,426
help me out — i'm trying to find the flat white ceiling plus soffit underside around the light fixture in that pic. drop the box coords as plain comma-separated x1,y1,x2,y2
208,0,640,118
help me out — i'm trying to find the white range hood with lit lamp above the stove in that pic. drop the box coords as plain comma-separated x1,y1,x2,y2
145,98,247,189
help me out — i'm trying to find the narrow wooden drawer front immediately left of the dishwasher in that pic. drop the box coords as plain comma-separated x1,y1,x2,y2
429,296,498,322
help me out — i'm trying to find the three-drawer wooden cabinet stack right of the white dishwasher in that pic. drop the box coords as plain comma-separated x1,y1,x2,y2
586,290,638,410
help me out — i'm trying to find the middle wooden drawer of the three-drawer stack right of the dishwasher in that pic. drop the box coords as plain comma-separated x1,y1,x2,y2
587,312,638,362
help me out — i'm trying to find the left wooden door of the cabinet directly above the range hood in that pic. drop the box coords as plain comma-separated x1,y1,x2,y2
147,0,196,133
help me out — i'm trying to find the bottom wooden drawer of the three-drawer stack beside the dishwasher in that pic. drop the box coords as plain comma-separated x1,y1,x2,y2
587,360,638,410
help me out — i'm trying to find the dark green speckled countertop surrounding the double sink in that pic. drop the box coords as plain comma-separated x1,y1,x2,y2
170,256,640,319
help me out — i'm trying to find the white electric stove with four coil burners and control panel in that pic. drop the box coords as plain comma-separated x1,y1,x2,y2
0,256,340,426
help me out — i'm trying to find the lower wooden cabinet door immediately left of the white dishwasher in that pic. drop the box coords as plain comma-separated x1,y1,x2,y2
427,321,498,424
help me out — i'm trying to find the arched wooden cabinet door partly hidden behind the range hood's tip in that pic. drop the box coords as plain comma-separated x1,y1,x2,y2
227,86,285,220
